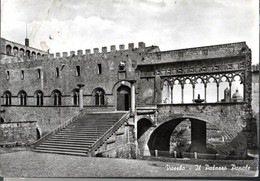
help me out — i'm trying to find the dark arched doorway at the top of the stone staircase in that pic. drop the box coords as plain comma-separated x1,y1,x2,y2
117,85,131,111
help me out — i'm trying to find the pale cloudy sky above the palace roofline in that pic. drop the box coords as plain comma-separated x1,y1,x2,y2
1,0,259,64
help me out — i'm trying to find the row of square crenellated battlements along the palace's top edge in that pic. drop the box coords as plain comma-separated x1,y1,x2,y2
49,42,146,58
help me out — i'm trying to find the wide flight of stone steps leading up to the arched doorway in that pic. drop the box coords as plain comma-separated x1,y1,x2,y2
34,112,126,156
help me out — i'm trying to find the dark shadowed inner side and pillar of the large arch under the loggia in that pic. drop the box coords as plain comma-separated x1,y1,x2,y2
148,118,207,156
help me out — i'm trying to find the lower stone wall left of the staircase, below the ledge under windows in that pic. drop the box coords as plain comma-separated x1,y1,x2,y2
0,106,79,142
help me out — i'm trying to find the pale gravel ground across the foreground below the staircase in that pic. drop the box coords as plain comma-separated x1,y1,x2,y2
0,151,258,177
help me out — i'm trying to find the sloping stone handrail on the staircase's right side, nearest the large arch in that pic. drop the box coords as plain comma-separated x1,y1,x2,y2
87,112,130,156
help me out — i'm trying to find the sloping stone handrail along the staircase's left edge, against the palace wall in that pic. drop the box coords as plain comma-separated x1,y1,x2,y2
33,111,83,148
